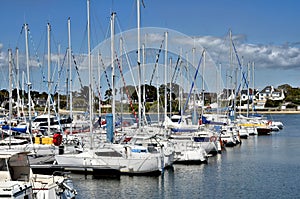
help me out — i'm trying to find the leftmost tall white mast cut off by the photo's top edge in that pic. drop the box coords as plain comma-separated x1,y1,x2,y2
87,0,93,149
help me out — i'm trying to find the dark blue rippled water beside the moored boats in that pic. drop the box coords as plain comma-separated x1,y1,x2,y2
72,115,300,199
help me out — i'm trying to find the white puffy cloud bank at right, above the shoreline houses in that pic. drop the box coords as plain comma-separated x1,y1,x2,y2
192,35,300,69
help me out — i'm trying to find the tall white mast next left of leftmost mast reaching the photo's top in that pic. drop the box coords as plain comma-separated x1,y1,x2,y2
68,17,73,135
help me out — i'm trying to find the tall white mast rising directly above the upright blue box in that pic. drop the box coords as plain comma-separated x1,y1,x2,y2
110,12,116,138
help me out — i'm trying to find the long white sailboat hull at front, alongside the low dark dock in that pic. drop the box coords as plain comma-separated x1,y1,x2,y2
55,145,163,174
